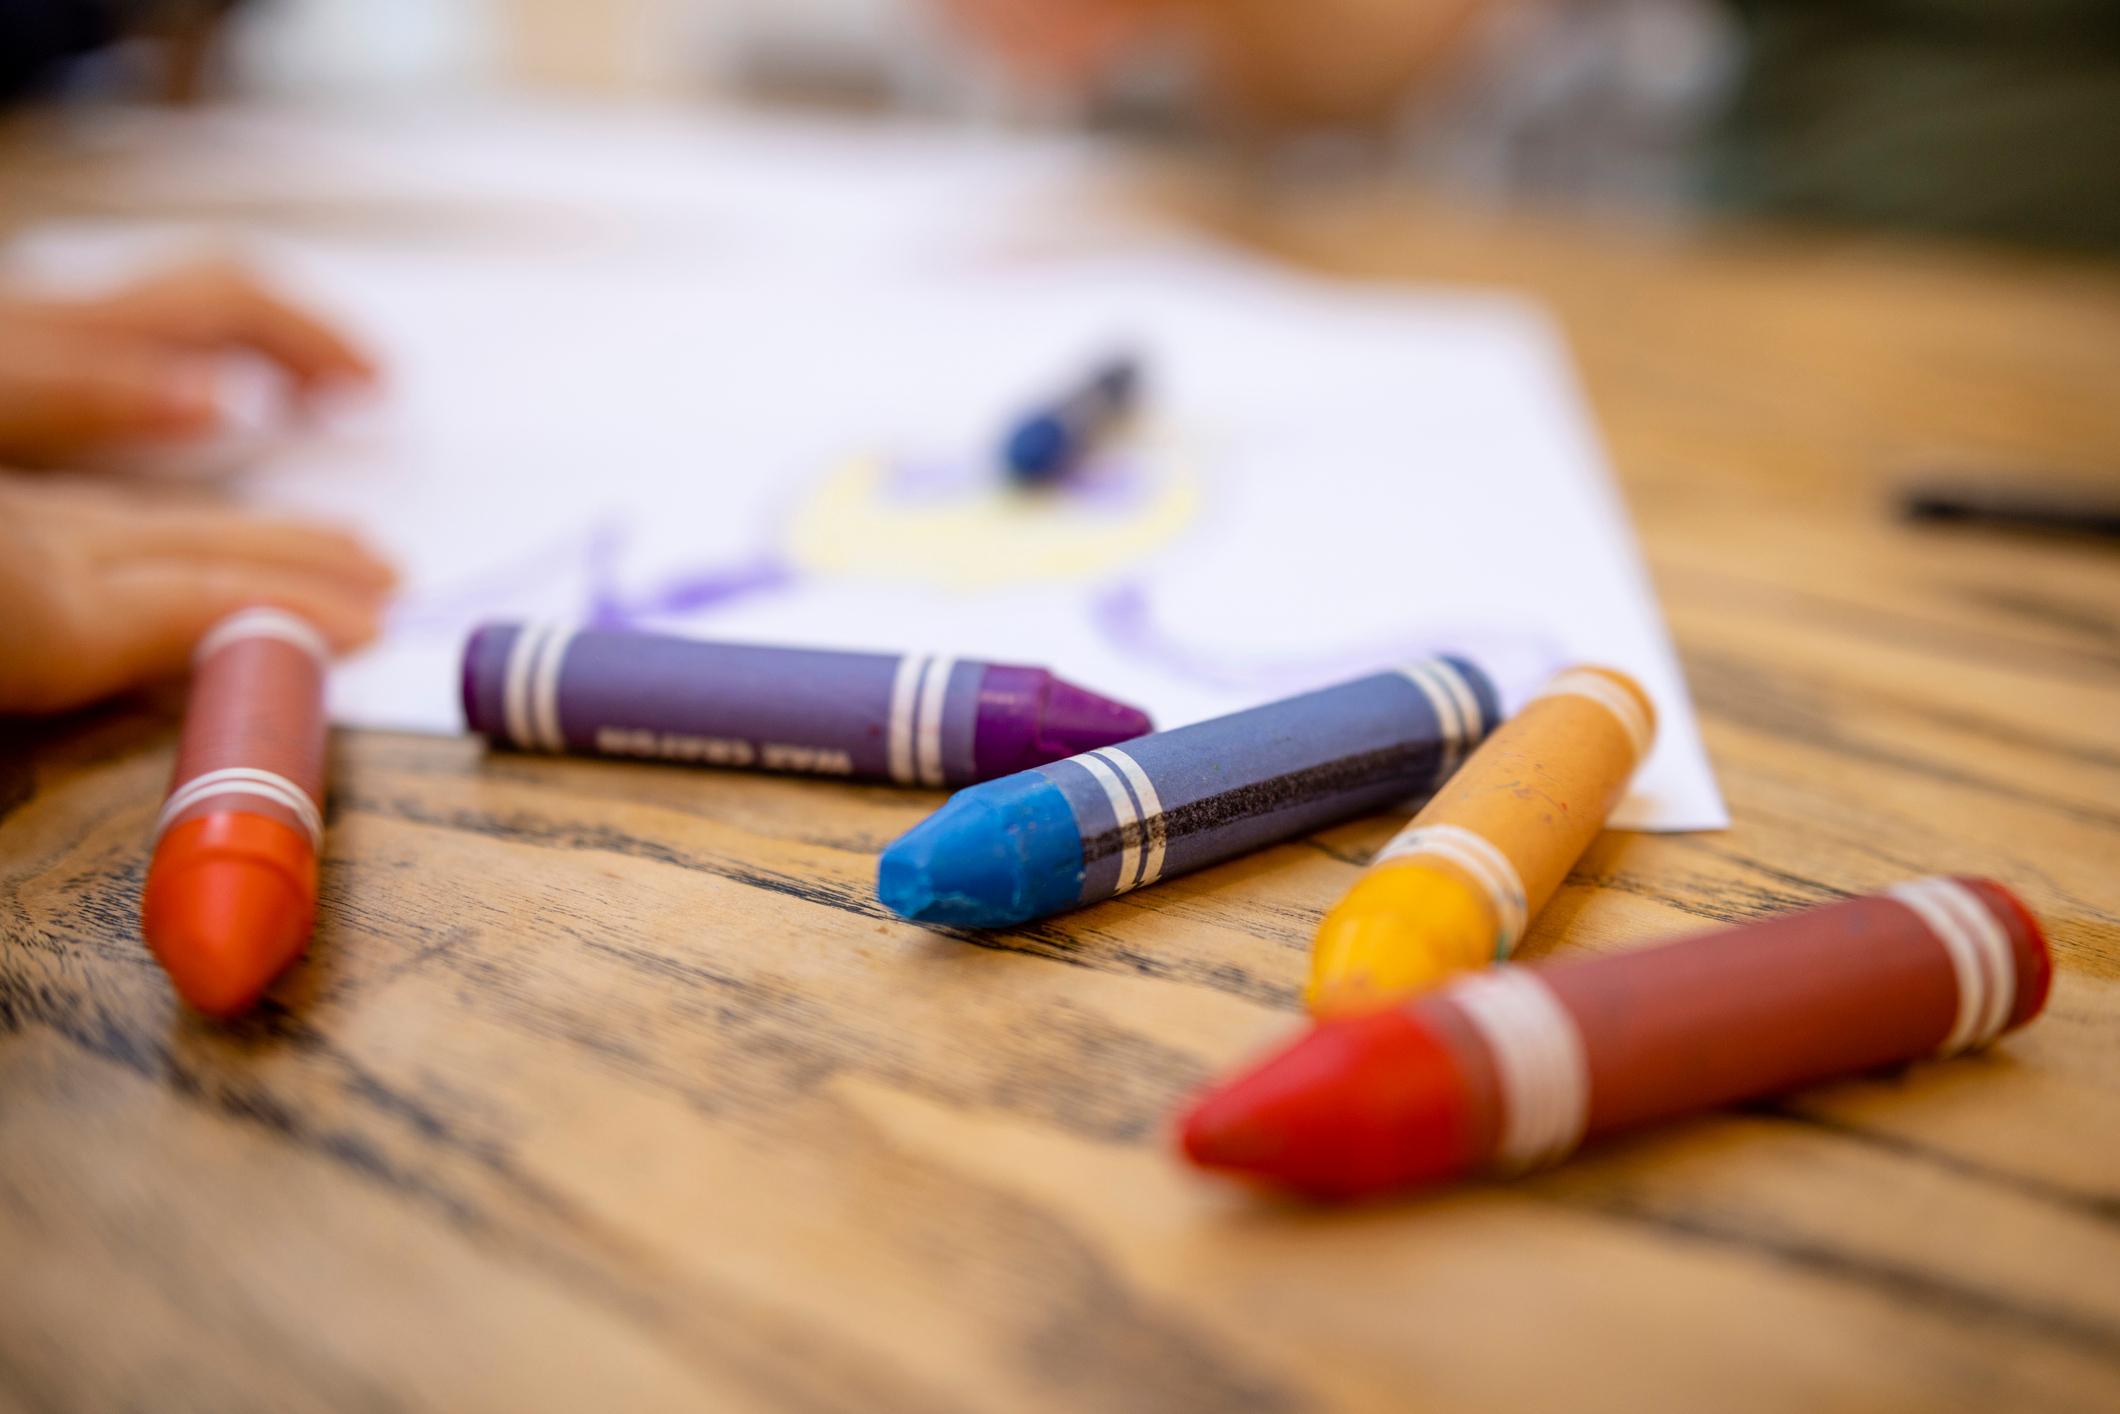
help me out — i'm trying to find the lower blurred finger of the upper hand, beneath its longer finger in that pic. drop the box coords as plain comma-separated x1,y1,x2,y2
0,326,218,464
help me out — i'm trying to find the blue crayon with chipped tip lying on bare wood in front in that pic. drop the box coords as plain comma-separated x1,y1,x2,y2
876,657,1501,926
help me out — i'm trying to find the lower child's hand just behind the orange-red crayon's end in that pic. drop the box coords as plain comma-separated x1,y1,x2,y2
0,475,394,712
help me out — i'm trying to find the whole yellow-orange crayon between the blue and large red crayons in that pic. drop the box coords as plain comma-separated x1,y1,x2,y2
1308,668,1656,1013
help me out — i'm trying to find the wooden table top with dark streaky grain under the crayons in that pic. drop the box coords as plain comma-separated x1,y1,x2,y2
0,127,2120,1410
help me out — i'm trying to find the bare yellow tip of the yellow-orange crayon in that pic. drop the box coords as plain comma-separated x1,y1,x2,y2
1304,861,1501,1015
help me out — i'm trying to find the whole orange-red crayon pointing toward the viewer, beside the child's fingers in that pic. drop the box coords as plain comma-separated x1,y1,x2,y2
140,608,329,1018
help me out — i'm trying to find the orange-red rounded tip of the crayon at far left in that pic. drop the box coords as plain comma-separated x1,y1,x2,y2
140,810,316,1018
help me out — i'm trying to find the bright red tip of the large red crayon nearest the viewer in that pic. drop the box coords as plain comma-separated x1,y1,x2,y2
1181,1009,1473,1198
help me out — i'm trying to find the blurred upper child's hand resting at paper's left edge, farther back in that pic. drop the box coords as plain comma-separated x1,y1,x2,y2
0,263,375,464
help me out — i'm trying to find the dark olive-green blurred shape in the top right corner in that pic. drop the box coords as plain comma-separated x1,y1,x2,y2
1713,0,2120,252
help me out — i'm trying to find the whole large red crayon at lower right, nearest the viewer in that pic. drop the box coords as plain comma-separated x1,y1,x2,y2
1183,878,2052,1198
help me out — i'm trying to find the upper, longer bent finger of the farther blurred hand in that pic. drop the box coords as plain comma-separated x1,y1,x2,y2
76,261,375,388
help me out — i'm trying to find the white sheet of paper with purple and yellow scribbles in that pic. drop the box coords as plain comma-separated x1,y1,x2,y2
8,211,1728,829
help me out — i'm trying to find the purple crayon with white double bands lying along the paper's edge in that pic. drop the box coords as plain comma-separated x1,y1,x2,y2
464,623,1153,786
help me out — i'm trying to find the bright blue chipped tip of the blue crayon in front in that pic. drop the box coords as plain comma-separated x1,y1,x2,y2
876,772,1081,929
